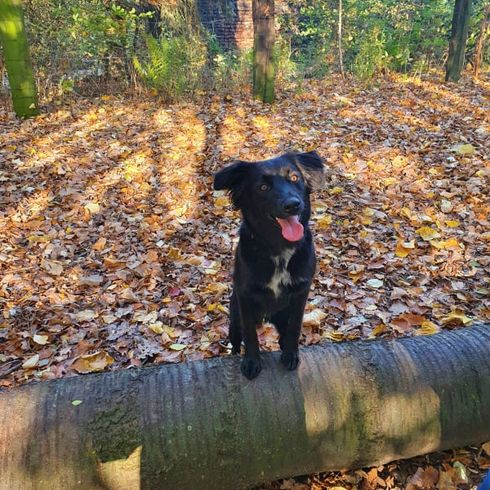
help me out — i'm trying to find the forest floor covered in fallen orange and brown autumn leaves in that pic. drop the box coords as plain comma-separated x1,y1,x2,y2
0,72,490,490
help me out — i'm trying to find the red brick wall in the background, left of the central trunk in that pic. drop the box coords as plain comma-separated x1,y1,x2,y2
197,0,253,50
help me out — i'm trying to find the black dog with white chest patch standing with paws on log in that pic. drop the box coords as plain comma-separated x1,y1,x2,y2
214,152,324,379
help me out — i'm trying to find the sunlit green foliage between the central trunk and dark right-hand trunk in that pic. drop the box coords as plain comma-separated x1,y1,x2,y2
280,0,460,80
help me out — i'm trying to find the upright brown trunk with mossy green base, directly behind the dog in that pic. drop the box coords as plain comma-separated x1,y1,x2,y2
252,0,275,103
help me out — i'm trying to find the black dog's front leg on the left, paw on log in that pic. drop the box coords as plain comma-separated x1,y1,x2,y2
237,295,262,379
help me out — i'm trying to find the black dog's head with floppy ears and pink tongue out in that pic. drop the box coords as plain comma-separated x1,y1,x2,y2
214,151,324,242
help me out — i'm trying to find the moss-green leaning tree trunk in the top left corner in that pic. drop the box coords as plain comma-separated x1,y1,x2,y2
0,0,39,117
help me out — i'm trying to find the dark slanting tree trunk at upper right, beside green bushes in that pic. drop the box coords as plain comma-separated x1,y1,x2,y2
446,0,471,82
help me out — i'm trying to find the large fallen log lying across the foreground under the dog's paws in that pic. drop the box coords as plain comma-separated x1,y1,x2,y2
0,325,490,490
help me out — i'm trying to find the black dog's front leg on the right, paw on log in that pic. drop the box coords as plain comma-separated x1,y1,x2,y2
278,291,308,371
